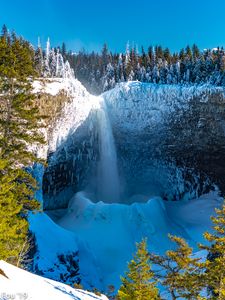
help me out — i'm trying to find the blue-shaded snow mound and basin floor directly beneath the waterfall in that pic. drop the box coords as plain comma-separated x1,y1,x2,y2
43,191,222,290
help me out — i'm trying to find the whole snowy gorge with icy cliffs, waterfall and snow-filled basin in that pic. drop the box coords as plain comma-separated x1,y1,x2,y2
30,78,225,291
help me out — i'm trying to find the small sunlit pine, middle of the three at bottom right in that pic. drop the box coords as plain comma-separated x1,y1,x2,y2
150,236,204,300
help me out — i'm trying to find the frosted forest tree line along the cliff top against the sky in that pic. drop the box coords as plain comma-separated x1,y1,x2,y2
59,43,225,94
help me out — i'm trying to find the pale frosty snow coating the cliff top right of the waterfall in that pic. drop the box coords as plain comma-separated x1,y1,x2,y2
102,81,223,134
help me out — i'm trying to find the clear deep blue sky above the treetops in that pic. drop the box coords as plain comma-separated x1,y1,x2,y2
0,0,225,51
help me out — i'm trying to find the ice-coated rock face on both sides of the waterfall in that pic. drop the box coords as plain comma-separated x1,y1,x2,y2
43,81,225,210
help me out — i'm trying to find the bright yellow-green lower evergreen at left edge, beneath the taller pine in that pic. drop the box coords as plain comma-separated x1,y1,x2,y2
0,159,29,265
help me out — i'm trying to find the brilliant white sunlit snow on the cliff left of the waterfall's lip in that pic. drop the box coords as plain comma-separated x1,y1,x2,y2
33,78,101,157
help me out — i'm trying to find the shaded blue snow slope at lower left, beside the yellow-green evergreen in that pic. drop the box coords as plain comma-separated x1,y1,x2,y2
29,209,102,289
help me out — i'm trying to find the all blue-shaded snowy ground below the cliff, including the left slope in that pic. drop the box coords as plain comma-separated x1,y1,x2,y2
30,192,223,291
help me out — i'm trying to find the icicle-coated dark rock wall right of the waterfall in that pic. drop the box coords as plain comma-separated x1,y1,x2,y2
103,82,225,202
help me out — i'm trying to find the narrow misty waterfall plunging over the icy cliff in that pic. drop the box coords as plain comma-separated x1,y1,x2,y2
97,97,120,203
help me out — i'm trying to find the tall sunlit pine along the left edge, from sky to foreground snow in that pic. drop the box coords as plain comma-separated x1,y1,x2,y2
0,28,44,264
